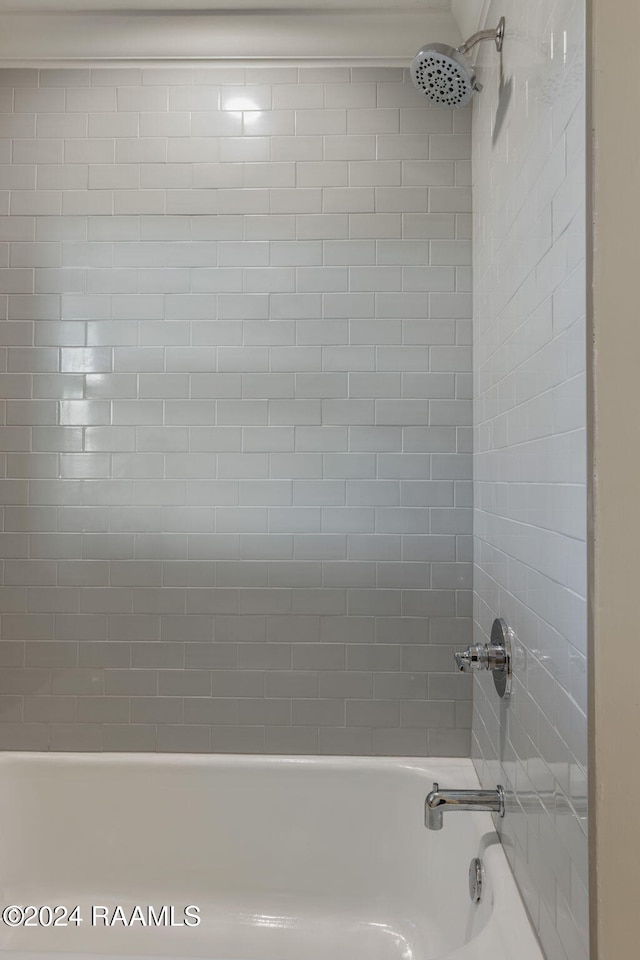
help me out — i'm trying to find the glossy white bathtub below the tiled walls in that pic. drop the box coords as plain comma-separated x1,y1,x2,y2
0,753,542,960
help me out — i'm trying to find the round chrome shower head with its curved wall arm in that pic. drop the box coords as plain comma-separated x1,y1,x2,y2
410,17,505,108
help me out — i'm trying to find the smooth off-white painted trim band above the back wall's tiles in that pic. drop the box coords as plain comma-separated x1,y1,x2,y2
0,9,460,66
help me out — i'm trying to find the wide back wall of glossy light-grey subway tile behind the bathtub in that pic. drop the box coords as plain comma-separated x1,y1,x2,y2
0,67,472,755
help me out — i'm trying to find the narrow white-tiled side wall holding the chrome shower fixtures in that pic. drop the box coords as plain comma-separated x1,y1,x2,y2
473,0,588,960
